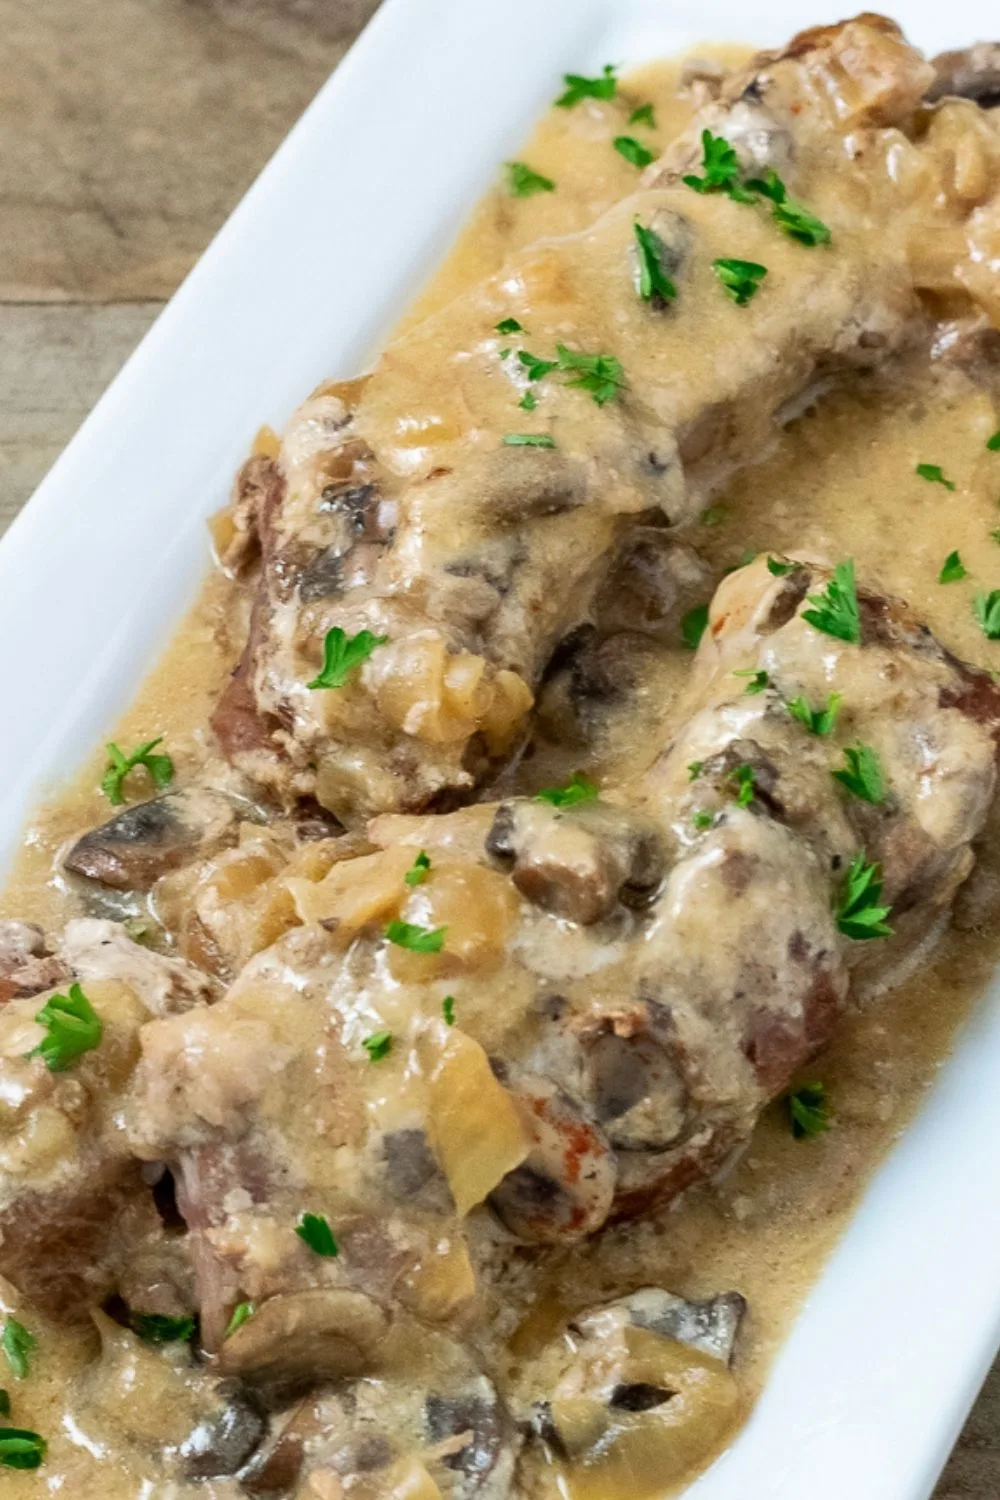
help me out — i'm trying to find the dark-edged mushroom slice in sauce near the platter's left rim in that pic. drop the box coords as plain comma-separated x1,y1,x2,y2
63,786,238,891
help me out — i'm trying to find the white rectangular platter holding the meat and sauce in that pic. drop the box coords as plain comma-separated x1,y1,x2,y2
0,0,1000,1500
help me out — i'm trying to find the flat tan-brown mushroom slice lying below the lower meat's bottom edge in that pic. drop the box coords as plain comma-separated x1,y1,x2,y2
217,1287,388,1401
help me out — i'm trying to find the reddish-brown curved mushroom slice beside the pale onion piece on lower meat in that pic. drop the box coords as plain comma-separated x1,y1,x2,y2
489,1064,615,1245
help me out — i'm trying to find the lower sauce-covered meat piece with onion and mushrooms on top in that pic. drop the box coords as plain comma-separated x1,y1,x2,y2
125,558,1000,1374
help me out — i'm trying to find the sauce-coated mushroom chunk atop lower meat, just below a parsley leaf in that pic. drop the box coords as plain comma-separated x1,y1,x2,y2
486,801,664,926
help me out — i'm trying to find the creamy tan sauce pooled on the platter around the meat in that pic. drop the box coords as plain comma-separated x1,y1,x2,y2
0,50,1000,1500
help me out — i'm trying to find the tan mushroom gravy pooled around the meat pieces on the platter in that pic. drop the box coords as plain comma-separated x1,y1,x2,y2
0,32,1000,1500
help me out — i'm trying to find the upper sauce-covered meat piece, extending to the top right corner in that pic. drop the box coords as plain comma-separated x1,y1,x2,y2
214,18,997,824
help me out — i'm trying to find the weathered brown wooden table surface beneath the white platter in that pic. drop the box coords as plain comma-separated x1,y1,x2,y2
0,0,1000,1500
